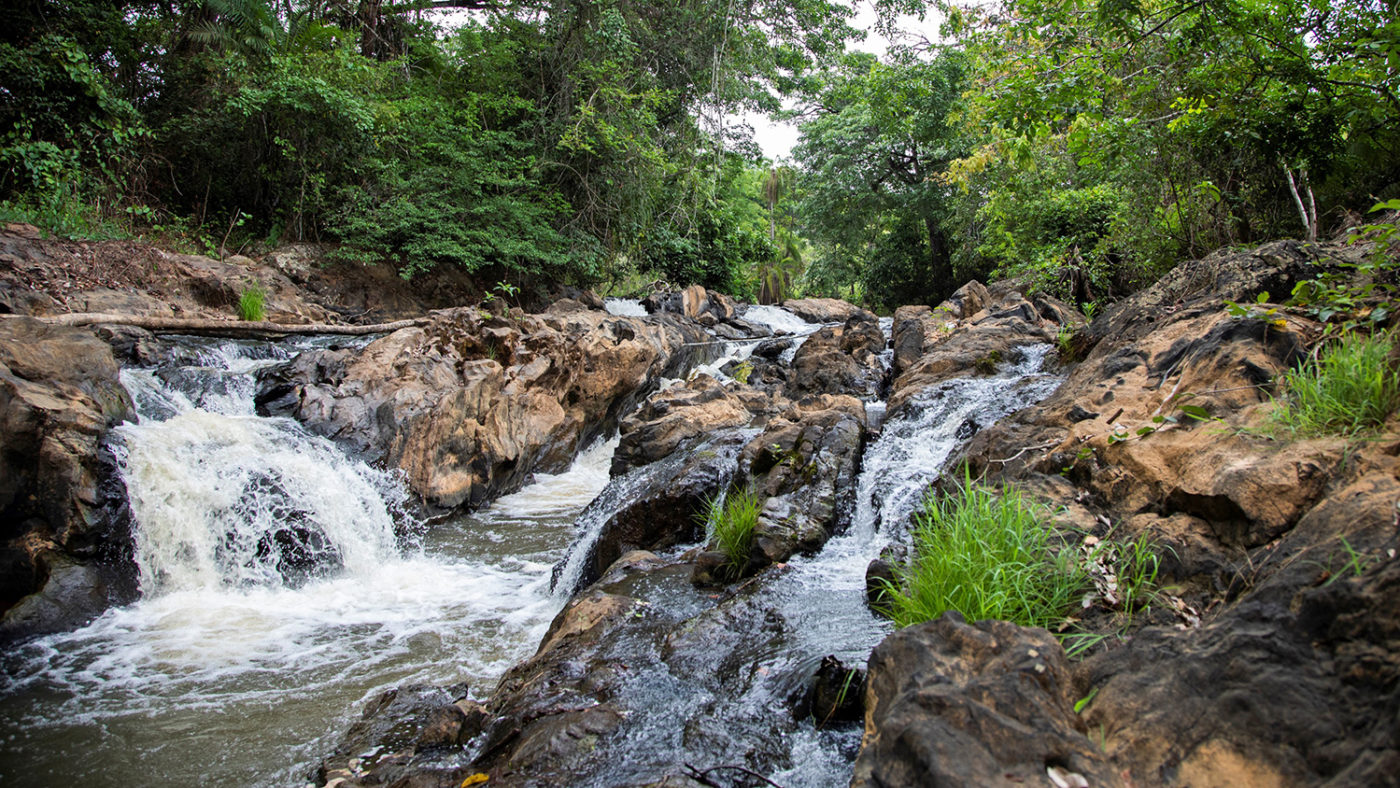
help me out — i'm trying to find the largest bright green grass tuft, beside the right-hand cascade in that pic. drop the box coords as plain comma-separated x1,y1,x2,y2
888,479,1089,627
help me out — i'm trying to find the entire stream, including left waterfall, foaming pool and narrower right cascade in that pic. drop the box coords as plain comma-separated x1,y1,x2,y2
0,304,1058,787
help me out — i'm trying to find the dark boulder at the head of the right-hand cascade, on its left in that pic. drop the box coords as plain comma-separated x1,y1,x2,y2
784,312,885,399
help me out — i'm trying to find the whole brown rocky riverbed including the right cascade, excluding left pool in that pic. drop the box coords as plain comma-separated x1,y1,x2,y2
0,228,1400,787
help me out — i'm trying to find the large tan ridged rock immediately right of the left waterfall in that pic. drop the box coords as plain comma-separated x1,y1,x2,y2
259,308,703,509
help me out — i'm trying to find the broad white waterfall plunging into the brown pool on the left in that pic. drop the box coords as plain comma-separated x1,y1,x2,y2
116,343,406,596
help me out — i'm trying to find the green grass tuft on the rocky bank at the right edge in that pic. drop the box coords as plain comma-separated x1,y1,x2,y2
1273,333,1400,435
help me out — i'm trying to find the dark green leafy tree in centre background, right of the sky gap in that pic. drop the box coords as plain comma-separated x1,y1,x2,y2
794,52,966,308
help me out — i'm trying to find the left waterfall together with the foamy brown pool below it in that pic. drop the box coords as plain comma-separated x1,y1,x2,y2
0,340,615,785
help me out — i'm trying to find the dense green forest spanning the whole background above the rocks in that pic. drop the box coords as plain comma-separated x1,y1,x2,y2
0,0,1400,308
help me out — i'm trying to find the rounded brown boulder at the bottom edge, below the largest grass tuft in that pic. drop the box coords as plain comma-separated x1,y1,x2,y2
851,613,1124,788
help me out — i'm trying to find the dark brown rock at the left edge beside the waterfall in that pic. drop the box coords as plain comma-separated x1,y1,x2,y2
0,318,136,637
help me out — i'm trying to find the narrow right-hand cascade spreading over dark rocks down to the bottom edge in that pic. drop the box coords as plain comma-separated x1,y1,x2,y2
529,346,1060,787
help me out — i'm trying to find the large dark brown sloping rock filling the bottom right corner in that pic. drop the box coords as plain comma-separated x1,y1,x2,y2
1081,473,1400,785
